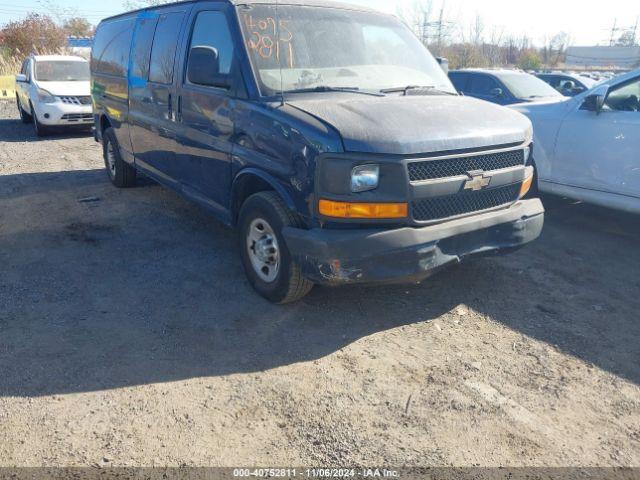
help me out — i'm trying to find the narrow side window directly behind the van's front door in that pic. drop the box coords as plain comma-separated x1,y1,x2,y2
149,13,184,85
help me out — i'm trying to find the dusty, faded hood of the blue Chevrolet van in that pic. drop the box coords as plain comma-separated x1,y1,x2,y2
287,93,532,155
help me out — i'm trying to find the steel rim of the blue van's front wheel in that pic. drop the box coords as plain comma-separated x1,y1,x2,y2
247,218,280,283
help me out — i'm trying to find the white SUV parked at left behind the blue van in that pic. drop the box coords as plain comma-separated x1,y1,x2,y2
16,55,93,136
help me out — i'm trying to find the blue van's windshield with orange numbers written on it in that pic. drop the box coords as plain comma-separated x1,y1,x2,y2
239,5,456,95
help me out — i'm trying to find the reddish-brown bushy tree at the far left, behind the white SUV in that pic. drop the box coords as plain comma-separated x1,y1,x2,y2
0,13,67,55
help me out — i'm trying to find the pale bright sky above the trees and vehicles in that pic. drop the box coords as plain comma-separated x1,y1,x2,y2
0,0,640,45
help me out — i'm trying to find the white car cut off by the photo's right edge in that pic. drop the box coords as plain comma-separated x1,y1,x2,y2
511,70,640,213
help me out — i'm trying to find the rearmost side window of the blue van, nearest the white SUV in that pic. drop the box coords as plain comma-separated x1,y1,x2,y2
91,19,134,78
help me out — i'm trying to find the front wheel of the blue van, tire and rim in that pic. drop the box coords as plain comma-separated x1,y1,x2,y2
238,192,313,305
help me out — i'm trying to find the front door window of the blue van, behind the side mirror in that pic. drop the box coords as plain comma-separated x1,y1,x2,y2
187,12,234,82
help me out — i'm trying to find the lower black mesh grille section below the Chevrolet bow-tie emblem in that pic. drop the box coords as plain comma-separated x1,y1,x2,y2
413,183,521,222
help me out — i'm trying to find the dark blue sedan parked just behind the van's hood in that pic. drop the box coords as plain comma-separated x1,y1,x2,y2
449,69,563,105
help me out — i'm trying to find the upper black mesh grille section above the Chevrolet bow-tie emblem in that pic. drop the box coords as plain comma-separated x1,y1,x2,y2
409,149,524,182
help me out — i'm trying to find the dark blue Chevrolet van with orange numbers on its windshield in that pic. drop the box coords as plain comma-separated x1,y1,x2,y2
91,0,544,303
